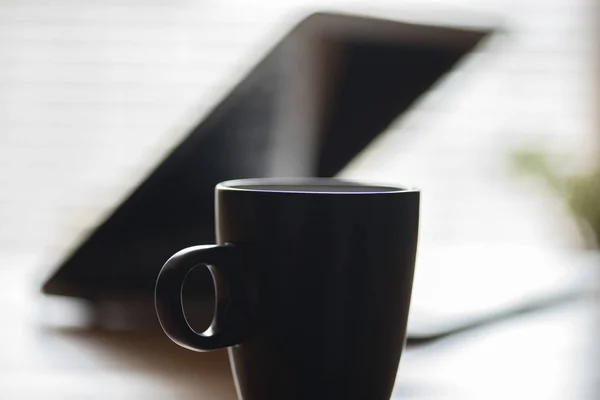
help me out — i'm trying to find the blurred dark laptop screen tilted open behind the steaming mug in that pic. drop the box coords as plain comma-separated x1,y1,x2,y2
42,13,500,338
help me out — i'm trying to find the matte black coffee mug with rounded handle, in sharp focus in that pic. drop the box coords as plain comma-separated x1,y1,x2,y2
155,178,420,400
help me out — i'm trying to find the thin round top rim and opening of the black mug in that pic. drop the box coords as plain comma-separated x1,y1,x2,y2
216,177,419,196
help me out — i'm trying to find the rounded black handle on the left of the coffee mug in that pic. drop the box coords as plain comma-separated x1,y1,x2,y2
154,244,249,351
